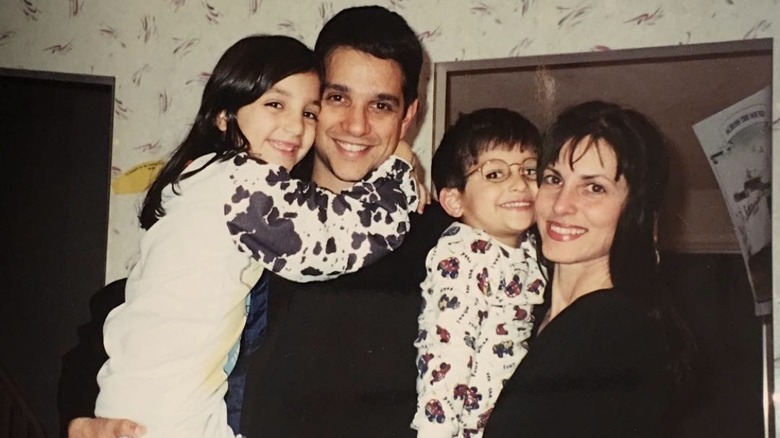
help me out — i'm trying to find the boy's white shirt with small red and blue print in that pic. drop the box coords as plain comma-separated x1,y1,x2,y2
412,223,545,438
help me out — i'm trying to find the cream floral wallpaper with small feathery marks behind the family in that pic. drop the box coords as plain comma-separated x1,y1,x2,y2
0,0,780,424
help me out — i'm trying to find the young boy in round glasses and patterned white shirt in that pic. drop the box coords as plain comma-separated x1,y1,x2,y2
412,108,545,438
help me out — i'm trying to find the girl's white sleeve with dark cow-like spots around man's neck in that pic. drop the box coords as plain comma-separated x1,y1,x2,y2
225,154,418,282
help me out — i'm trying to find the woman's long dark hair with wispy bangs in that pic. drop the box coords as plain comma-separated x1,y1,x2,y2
537,101,695,383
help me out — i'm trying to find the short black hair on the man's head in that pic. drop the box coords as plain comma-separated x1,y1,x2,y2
314,6,423,109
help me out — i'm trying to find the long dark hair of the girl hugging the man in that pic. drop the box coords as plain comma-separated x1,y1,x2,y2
139,35,317,229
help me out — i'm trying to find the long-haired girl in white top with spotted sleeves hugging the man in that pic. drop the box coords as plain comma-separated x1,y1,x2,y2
95,36,417,438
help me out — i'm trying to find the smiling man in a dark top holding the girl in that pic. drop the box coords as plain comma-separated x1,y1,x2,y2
70,6,451,438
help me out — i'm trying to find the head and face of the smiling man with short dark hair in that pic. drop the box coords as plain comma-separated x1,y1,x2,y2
311,11,422,189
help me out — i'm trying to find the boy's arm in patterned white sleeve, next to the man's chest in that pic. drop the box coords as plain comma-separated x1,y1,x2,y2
413,241,487,437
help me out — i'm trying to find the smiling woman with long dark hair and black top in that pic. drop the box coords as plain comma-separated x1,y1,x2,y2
484,102,684,438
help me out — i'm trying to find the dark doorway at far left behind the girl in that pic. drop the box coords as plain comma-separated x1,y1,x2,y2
0,69,114,437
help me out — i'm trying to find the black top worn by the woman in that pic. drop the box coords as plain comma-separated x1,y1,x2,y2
484,289,672,438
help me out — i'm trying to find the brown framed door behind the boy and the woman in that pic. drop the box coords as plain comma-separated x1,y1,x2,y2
433,39,780,438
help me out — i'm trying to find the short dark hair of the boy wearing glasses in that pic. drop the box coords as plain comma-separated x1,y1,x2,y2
431,108,541,193
